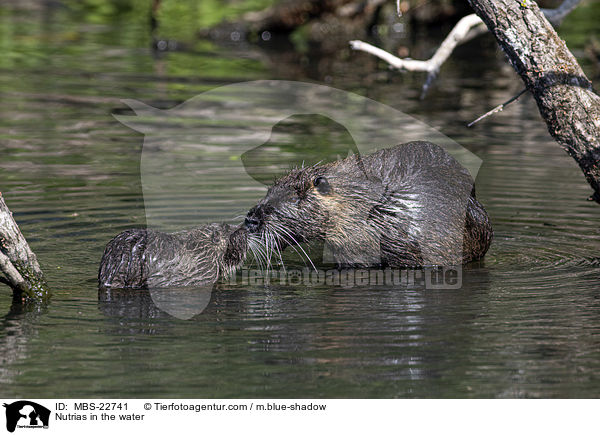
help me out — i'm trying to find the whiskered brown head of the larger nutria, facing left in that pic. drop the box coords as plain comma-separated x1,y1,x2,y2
244,156,390,264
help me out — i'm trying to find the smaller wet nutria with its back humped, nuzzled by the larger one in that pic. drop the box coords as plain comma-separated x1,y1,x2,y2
98,224,248,288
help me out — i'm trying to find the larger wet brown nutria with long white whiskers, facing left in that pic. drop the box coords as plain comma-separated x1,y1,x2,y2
245,141,493,267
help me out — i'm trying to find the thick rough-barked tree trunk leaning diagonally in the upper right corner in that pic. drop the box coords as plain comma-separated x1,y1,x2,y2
469,0,600,203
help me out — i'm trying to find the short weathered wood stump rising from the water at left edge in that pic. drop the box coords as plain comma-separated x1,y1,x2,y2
0,193,50,300
